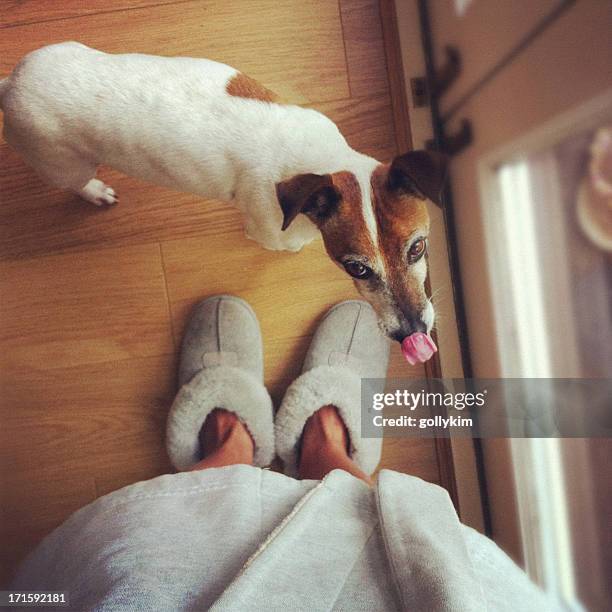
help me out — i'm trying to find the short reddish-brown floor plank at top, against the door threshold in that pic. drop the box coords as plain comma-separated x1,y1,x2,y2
340,0,388,97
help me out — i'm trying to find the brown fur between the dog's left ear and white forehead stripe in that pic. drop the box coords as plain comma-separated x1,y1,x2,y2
321,171,376,262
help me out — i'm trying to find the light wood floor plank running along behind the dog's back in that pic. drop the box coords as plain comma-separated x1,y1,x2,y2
0,0,349,104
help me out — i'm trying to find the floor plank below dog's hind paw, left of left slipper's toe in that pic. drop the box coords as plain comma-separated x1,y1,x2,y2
0,244,173,370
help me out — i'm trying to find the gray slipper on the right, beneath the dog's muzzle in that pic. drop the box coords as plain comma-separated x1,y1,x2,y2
274,300,390,476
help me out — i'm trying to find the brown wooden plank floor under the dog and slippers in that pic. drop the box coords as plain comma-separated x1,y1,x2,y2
0,0,440,581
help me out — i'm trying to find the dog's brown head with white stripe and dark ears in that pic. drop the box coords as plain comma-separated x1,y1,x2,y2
276,151,446,342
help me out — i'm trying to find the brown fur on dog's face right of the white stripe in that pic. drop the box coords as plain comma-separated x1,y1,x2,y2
371,165,429,307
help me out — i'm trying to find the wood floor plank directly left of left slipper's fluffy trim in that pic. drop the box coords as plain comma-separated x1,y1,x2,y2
0,356,176,485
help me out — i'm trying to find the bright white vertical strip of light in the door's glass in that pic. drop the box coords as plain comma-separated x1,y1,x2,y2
498,158,580,609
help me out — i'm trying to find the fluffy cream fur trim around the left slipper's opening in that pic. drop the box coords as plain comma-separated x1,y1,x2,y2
166,366,274,470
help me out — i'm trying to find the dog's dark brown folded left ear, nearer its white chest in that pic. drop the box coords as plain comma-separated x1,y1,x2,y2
276,174,340,231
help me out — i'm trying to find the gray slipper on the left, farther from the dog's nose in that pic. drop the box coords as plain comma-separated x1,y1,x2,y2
166,295,274,470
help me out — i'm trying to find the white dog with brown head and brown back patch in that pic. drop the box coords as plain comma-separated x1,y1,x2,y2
0,42,445,341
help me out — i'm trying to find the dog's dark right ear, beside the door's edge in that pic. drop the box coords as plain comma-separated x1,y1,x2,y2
387,151,448,206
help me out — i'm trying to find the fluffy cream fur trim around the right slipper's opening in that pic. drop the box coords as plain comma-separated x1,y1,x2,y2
274,365,382,476
